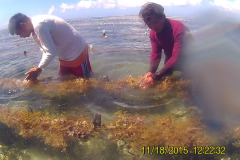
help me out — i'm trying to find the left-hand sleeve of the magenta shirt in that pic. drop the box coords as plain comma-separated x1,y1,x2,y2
149,30,162,73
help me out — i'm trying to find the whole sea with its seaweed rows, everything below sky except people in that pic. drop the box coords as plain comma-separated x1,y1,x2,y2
0,16,240,160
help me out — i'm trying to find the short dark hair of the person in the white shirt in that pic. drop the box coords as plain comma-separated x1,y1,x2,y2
8,13,29,35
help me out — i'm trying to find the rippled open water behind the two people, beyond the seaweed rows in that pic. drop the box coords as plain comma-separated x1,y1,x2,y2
0,16,197,79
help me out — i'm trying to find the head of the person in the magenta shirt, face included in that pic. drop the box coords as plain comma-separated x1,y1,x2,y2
139,3,166,32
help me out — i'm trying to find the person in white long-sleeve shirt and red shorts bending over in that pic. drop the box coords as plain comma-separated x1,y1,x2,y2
8,13,92,81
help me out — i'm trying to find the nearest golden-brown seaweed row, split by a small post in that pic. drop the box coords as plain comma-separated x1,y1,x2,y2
0,108,239,157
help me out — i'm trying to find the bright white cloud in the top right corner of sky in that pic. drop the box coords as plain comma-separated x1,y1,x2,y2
211,0,240,11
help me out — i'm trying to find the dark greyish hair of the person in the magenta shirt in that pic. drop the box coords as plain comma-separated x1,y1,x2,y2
139,2,164,20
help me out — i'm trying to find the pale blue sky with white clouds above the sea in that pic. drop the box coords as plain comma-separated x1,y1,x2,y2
0,0,240,29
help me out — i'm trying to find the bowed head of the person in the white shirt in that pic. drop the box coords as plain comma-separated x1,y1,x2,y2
8,13,34,38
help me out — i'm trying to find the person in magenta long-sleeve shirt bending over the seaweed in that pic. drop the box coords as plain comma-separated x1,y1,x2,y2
139,3,189,89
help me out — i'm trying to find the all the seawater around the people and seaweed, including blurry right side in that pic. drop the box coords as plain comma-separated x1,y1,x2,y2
0,16,240,160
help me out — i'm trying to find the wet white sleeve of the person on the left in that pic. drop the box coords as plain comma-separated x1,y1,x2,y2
35,22,57,68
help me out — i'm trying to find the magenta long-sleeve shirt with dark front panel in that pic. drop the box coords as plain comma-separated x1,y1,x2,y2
149,18,189,80
